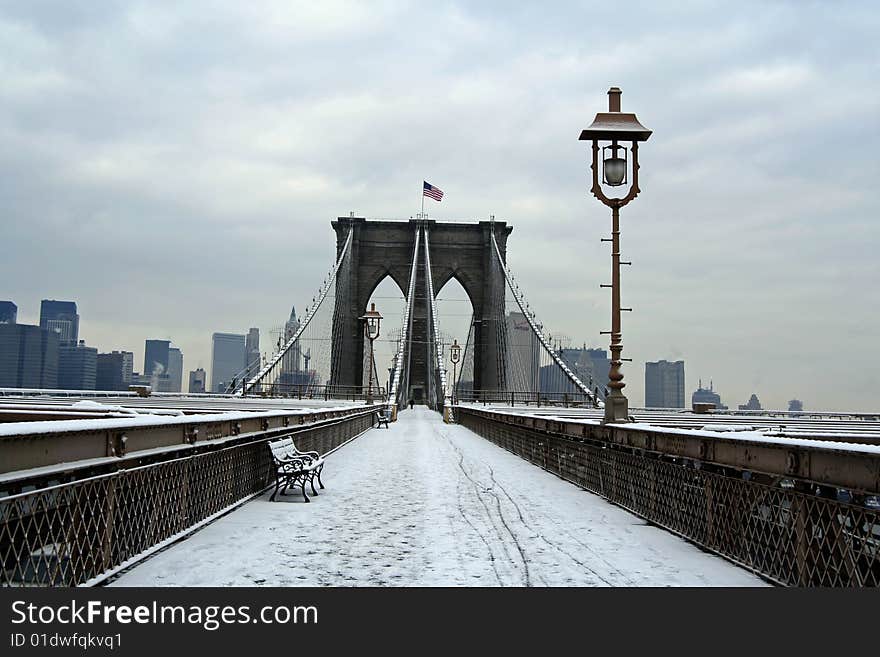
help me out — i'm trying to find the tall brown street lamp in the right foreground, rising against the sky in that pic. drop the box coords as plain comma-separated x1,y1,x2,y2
580,87,651,422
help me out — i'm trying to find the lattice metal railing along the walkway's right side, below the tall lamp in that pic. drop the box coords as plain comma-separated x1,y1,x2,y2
458,407,880,586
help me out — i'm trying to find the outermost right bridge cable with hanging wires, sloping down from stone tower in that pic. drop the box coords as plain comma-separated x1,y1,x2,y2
484,230,604,407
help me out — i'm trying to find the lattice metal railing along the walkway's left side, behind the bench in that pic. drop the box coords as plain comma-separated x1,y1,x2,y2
0,411,373,586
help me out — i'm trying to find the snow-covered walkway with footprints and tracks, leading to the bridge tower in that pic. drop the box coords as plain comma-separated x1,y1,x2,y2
113,408,763,586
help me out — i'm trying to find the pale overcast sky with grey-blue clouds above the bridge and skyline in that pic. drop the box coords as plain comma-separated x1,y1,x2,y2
0,0,880,410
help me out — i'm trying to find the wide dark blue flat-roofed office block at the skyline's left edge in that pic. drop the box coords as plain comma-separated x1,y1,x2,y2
0,323,58,389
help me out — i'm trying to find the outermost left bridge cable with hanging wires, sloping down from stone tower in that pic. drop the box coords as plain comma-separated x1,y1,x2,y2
236,229,354,396
